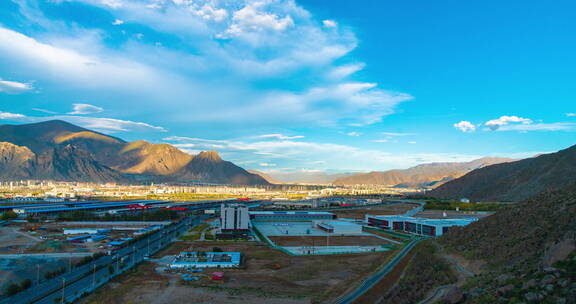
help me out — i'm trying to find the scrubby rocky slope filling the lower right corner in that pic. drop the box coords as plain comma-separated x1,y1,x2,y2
438,185,576,303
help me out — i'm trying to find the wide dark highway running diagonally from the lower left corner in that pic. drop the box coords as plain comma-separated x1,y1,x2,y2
0,216,207,304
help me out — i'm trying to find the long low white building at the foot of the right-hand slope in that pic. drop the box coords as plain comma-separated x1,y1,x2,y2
366,214,478,236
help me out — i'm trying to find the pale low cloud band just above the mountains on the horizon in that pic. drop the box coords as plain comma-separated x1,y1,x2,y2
164,136,528,171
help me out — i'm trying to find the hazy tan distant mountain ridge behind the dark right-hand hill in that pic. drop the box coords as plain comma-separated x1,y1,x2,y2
334,157,513,187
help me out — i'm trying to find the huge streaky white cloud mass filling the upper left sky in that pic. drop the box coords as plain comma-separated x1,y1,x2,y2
0,0,412,129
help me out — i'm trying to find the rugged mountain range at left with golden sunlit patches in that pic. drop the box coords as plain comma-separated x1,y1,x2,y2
0,120,268,185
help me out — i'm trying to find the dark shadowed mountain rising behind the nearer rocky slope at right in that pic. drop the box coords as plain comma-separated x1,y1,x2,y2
429,146,576,201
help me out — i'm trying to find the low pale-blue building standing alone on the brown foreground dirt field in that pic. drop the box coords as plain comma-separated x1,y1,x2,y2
168,252,241,269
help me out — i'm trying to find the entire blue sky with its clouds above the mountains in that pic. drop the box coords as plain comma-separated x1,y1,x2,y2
0,0,576,172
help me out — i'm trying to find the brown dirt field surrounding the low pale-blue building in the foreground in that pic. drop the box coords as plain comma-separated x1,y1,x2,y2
81,242,390,304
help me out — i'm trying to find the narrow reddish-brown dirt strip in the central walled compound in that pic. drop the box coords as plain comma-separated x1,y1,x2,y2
269,236,390,246
